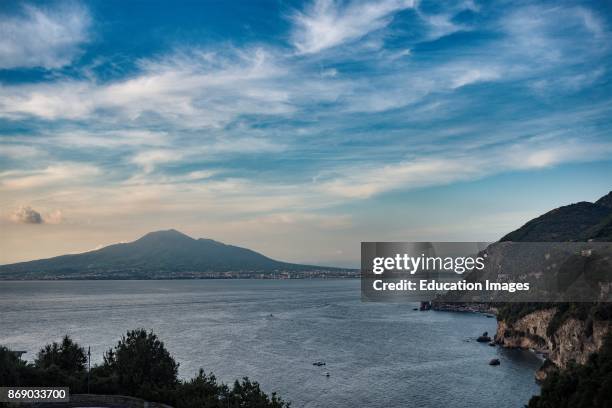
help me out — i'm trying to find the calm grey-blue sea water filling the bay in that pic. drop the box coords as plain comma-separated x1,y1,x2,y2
0,280,540,408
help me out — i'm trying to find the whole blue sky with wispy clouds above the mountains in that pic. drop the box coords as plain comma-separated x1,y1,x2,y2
0,0,612,267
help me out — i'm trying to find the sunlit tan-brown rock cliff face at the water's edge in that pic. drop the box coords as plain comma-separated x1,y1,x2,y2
495,308,612,381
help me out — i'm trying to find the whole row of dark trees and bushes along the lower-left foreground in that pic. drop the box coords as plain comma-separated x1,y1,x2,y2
0,329,290,408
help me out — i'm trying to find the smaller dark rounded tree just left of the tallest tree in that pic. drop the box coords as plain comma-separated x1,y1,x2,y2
35,335,87,374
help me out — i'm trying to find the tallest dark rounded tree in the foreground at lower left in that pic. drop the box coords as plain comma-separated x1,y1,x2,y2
104,329,178,397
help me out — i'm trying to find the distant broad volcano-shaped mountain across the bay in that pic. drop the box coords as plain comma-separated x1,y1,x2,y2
0,229,352,279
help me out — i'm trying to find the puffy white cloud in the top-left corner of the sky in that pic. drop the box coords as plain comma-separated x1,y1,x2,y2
0,4,91,69
